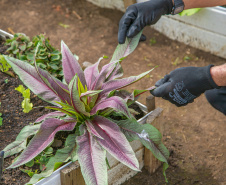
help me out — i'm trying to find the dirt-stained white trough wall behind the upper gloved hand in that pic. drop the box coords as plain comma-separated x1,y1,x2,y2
87,0,226,58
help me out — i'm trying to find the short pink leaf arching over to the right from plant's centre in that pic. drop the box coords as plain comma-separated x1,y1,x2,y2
90,96,131,117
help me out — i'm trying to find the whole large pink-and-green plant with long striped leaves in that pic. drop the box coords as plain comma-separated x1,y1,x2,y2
4,33,169,185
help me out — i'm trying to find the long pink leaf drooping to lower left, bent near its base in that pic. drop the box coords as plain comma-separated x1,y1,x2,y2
8,118,76,168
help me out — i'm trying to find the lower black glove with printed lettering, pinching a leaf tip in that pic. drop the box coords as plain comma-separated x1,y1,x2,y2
151,65,219,107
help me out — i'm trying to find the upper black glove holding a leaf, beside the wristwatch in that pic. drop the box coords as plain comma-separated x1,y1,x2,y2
118,0,173,44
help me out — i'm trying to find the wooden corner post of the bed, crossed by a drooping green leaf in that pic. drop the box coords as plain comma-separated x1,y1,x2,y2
144,108,163,174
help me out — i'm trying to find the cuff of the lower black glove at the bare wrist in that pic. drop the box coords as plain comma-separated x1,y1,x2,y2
203,64,220,90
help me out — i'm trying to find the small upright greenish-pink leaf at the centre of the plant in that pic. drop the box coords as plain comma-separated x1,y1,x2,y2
69,75,89,116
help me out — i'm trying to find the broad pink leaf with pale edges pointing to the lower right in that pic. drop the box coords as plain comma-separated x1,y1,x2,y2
92,116,140,171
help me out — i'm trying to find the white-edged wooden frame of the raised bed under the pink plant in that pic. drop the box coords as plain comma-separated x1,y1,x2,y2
35,100,163,185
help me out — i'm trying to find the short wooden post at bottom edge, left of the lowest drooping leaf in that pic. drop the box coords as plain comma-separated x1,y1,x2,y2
60,161,85,185
